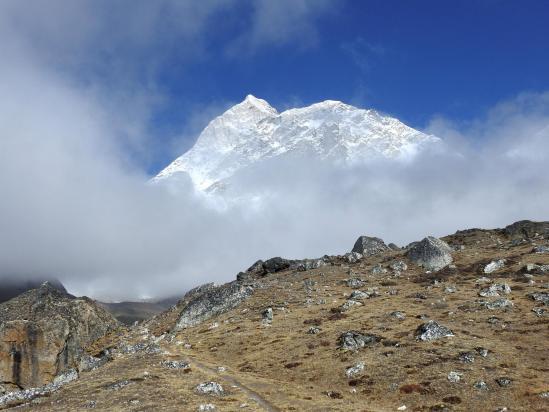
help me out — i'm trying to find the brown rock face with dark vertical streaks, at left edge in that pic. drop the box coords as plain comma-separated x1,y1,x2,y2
0,282,119,388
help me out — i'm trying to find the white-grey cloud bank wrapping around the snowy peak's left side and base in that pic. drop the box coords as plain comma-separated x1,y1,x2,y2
0,1,549,299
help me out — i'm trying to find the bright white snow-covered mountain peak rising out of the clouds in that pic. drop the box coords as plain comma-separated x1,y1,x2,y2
153,95,440,191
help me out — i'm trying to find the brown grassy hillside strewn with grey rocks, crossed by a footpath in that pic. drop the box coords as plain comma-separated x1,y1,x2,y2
0,222,549,411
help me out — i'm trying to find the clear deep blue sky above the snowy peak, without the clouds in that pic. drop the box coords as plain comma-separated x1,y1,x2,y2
148,0,549,171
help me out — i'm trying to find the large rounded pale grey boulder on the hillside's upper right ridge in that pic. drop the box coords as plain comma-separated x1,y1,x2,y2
407,236,452,271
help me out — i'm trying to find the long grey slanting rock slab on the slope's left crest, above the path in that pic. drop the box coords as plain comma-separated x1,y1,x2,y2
175,282,253,330
